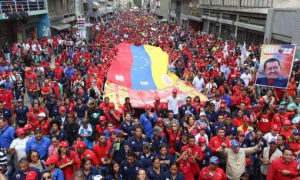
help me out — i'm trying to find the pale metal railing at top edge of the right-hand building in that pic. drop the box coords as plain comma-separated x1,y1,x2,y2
200,0,273,8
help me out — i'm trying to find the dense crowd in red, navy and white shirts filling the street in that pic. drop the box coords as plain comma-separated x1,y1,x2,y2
0,8,300,180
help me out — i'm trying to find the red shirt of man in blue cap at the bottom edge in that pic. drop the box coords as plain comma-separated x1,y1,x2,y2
199,166,227,180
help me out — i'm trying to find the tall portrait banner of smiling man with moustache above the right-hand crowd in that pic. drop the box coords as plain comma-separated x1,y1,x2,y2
255,44,296,88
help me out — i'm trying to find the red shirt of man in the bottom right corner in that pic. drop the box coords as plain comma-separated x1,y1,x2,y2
267,157,298,180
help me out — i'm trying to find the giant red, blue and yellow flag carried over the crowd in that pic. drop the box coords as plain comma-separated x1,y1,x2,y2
105,43,207,107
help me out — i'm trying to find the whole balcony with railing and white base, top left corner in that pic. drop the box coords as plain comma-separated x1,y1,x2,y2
0,0,47,19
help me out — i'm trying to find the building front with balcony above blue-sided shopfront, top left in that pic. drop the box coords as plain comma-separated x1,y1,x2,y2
0,0,50,47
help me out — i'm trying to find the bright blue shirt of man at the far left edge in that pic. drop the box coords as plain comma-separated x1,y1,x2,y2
0,125,15,148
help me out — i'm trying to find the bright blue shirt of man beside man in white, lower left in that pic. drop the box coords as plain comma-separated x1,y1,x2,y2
25,137,51,159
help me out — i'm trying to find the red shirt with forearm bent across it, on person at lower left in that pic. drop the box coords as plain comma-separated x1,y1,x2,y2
56,151,80,179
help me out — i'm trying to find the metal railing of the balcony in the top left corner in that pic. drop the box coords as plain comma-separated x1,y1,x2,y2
0,0,46,14
